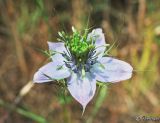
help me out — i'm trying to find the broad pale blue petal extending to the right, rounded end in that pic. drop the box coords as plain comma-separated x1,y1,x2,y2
91,57,133,82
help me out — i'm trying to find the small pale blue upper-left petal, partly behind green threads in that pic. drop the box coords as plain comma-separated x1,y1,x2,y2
48,42,67,62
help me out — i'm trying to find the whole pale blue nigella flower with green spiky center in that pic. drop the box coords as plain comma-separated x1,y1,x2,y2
33,28,133,110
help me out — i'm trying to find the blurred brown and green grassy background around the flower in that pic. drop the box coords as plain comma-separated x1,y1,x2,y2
0,0,160,123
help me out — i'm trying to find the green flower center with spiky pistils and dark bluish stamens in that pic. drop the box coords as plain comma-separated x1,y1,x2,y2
57,28,97,73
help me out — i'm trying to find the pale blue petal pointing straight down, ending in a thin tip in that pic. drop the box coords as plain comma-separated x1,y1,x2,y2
68,73,96,111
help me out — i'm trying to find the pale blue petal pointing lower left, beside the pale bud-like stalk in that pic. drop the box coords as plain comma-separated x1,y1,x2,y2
33,62,70,83
